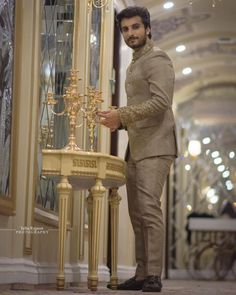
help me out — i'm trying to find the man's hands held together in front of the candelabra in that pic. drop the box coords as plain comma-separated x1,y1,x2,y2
97,109,121,132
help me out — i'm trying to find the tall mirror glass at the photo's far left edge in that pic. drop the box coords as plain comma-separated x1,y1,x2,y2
0,0,15,198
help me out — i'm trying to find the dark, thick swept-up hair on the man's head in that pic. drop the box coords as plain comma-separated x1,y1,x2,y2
116,6,152,39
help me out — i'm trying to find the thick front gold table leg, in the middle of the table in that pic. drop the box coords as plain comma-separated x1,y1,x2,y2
88,179,106,291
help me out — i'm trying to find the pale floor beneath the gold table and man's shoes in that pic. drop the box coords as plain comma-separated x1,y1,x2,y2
0,280,236,295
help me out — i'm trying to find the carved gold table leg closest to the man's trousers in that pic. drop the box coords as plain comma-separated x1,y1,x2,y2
109,188,121,290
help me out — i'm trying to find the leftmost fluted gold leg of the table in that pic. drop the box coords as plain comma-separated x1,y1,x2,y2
57,176,72,290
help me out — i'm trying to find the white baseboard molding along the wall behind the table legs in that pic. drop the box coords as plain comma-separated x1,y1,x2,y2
0,257,110,285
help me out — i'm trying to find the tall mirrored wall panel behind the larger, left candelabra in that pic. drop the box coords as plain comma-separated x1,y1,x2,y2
36,0,74,211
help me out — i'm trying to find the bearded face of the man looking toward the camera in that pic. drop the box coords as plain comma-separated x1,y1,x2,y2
121,16,150,50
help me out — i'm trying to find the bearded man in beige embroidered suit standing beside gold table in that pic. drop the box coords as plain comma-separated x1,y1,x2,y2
98,6,177,292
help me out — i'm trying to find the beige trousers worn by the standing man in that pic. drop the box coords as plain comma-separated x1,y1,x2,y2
126,156,174,277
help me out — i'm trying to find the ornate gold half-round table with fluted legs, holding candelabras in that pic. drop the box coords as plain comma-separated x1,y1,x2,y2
42,149,125,290
